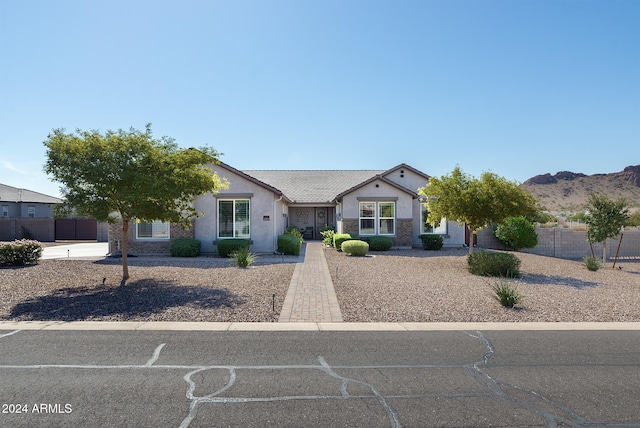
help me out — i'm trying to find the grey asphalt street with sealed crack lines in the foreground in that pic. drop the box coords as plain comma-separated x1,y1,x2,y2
0,330,640,427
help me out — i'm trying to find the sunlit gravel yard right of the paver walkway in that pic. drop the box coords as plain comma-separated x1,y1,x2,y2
325,248,640,322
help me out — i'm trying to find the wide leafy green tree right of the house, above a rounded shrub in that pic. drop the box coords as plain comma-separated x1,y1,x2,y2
418,167,539,253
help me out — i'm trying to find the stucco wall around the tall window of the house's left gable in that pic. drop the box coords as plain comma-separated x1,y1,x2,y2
194,165,286,253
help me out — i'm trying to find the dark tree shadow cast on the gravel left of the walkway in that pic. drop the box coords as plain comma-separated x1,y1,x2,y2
5,279,245,321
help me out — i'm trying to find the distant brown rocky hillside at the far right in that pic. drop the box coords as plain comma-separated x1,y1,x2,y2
520,165,640,212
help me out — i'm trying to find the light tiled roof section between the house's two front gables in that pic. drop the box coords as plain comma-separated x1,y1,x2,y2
244,170,385,204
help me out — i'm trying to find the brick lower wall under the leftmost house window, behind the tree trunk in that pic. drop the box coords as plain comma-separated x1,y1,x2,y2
109,220,195,256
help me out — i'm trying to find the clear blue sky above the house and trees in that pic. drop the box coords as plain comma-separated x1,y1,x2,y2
0,0,640,195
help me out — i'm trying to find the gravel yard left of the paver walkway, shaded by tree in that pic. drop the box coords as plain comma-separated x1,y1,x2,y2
0,258,295,322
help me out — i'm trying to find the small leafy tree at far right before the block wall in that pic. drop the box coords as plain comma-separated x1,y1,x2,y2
584,193,629,266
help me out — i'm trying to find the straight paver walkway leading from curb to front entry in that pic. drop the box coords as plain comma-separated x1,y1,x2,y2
278,242,342,322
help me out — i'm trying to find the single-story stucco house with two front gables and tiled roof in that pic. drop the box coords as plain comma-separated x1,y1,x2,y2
109,162,465,255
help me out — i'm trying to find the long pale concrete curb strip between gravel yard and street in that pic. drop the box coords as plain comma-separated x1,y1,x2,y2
0,321,640,332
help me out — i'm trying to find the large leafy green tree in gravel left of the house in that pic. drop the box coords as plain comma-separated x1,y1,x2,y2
44,124,226,284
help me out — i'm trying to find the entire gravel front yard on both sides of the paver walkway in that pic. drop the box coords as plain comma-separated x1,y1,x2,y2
0,248,640,322
